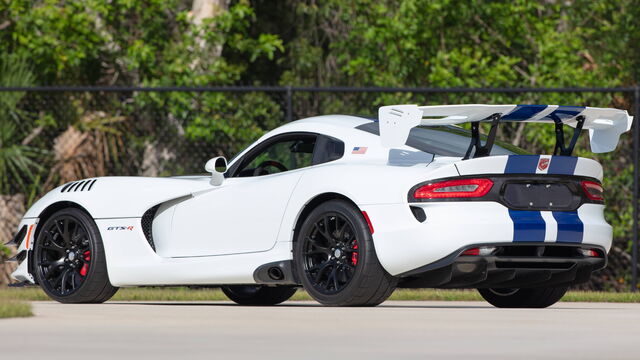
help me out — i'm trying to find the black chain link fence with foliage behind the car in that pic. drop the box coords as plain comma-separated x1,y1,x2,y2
0,87,640,291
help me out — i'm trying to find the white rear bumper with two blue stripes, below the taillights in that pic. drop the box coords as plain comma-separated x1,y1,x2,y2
360,201,613,276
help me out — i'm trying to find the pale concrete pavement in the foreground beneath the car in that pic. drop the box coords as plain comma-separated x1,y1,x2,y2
0,301,640,360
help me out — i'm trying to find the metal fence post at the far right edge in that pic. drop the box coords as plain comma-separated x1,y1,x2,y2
631,85,640,292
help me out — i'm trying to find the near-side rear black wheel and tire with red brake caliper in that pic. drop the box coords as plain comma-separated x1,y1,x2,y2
293,200,398,306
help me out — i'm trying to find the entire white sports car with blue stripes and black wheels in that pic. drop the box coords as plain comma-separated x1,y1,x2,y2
5,105,632,307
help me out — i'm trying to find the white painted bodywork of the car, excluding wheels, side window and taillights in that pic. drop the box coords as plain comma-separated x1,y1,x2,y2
13,105,631,287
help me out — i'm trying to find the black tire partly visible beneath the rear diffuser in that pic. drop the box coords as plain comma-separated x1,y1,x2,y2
478,286,568,308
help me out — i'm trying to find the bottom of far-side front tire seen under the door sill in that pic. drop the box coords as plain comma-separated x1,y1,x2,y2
222,285,297,306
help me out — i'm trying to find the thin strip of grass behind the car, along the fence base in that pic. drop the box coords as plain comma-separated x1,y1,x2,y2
0,287,640,303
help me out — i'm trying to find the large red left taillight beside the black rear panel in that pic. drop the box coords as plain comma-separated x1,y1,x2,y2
413,179,493,199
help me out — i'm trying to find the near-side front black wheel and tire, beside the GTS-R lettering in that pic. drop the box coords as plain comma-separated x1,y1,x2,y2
32,208,118,303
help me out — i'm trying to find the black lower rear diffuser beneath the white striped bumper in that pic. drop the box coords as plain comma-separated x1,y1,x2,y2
399,243,607,288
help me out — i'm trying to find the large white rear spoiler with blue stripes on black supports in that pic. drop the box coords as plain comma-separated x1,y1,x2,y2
378,104,633,158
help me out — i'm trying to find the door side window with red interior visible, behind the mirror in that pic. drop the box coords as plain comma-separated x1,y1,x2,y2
235,135,316,177
